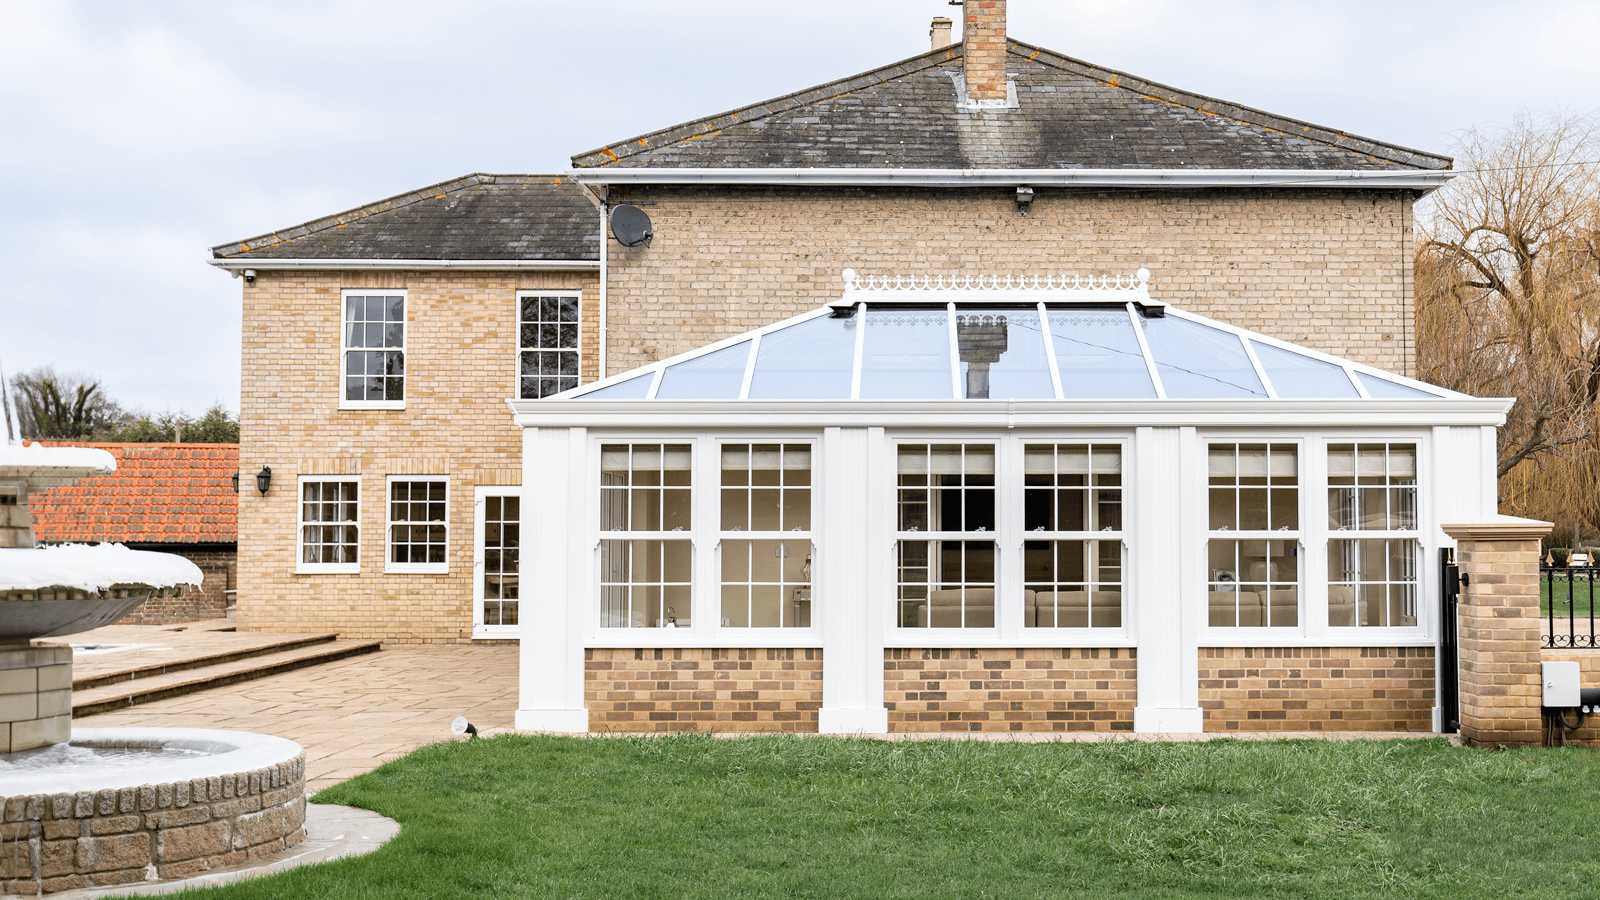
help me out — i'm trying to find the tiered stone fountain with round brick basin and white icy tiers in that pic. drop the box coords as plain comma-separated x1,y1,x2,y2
0,444,306,897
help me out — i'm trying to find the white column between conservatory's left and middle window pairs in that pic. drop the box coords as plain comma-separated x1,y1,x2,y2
813,428,893,735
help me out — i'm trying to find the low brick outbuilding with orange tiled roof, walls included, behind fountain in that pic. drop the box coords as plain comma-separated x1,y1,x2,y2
32,440,238,625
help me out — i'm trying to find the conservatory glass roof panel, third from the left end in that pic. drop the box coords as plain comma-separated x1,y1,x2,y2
749,315,856,400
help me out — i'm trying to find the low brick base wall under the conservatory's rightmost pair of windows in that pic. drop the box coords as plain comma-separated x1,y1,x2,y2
1200,647,1434,732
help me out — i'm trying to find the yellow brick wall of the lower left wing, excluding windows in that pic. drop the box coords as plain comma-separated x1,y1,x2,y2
237,269,598,642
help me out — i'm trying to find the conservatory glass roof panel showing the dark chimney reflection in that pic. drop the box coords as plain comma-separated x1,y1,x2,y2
955,307,1056,400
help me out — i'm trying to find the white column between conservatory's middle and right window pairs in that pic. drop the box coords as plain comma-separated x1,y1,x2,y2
1123,428,1205,733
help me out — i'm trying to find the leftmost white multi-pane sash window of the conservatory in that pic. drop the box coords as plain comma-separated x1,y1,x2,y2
600,444,694,628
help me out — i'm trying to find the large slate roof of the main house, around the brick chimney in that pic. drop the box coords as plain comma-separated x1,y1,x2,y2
573,40,1451,170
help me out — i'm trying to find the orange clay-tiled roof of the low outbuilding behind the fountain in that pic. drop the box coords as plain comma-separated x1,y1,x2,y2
29,440,236,544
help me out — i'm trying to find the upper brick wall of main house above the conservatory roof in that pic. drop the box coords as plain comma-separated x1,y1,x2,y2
606,186,1414,375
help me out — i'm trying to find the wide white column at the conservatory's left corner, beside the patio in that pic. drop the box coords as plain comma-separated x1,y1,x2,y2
517,428,594,732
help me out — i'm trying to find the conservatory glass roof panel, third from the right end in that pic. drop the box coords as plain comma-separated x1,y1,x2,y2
1142,315,1267,399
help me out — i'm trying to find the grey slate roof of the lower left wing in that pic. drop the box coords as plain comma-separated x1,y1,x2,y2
211,175,600,259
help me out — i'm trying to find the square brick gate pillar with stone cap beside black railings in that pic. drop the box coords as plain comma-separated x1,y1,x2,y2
1443,516,1550,746
